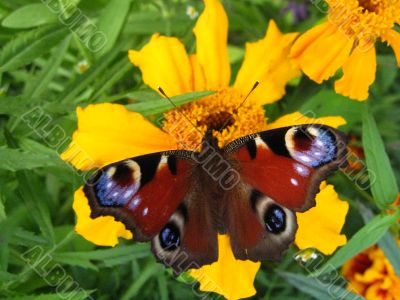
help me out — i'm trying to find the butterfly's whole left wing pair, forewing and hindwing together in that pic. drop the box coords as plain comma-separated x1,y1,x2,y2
84,151,218,274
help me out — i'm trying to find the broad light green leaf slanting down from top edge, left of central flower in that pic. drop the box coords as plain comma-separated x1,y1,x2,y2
96,0,131,57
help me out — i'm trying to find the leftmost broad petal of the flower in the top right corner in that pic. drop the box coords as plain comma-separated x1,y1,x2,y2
291,23,353,83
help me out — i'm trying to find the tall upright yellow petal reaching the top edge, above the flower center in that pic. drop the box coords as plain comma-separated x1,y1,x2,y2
193,0,231,90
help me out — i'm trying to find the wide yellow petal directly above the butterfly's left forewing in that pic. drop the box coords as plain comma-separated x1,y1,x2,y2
61,103,177,170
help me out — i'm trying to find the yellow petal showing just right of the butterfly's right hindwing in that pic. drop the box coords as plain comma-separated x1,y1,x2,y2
295,182,349,255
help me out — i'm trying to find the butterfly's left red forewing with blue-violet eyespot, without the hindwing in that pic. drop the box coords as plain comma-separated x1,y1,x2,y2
84,153,192,240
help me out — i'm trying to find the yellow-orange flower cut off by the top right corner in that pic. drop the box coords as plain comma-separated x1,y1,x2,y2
291,0,400,101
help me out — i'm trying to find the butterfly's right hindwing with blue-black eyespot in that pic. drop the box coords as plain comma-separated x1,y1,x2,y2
226,184,297,261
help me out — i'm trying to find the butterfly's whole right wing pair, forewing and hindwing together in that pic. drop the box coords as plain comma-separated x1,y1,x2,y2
225,124,346,261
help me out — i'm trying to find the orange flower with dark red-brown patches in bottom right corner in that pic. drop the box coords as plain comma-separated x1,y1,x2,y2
342,246,400,300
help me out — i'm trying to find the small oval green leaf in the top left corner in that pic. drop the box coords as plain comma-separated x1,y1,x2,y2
1,3,57,29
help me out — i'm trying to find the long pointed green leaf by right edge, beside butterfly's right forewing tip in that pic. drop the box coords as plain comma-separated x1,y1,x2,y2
362,109,399,209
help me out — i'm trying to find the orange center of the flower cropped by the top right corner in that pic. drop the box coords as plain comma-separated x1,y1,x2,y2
326,0,400,44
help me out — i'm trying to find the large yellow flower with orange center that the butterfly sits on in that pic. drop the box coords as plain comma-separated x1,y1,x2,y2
62,0,348,299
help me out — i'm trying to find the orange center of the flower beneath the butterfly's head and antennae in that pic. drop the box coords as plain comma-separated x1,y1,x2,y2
163,88,265,149
